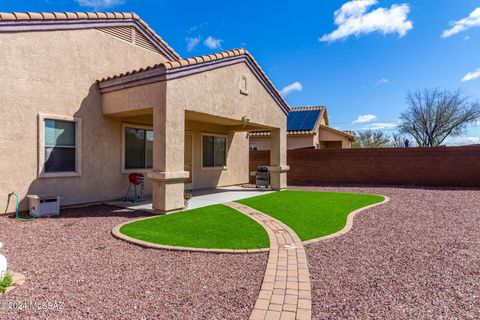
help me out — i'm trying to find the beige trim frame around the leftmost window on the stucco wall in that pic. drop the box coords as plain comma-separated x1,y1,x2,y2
38,113,82,178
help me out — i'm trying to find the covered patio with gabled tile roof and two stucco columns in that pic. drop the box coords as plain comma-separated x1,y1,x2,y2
99,50,289,213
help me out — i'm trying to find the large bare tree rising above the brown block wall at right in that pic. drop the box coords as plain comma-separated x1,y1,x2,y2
399,89,480,147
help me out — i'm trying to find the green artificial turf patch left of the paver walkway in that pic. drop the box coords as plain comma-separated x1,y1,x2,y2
120,205,269,249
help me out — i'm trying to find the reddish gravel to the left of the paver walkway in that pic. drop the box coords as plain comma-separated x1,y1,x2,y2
0,206,267,320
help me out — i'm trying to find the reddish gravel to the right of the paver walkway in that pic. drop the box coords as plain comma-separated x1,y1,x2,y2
288,187,480,319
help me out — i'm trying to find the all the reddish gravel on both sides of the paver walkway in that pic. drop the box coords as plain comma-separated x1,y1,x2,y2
0,187,480,320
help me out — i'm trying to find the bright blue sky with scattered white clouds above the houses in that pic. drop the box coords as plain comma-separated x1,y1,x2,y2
0,0,480,144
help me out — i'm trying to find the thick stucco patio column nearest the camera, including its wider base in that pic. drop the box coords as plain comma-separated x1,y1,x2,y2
148,97,188,214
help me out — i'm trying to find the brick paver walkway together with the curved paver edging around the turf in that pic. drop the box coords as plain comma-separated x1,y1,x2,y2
112,196,389,320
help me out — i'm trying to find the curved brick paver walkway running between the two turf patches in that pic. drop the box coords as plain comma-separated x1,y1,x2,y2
225,202,312,320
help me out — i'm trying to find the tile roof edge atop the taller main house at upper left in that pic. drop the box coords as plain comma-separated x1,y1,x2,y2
0,12,180,59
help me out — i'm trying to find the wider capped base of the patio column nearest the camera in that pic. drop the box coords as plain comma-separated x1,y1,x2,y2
147,171,189,214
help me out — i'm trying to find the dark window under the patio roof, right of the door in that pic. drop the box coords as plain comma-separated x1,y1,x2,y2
202,135,227,168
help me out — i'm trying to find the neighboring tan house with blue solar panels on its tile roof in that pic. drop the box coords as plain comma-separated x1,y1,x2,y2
250,106,354,150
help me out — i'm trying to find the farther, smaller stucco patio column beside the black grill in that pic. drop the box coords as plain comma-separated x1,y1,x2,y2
268,128,290,190
